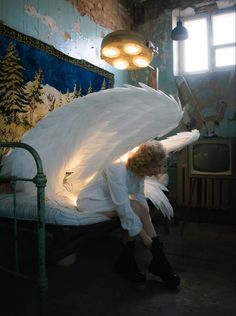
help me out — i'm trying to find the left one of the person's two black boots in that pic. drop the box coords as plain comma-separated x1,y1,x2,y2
115,241,146,282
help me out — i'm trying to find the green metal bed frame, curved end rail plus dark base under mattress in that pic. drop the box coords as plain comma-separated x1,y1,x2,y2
0,142,120,316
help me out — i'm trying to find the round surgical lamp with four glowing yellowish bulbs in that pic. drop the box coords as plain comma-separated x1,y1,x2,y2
101,30,155,70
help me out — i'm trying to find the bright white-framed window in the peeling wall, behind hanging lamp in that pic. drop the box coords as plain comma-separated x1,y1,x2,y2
174,11,236,75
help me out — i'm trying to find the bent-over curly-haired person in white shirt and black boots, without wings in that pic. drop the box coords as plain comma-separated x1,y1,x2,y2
77,141,180,286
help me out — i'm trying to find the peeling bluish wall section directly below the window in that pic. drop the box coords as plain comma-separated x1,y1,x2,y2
186,70,236,137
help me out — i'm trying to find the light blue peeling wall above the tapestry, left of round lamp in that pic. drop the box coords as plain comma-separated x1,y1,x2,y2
0,0,131,86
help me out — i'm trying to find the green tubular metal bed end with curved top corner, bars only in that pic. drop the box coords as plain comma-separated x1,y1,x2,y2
0,142,48,316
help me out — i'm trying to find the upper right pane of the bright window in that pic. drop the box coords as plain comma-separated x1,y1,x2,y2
212,12,236,45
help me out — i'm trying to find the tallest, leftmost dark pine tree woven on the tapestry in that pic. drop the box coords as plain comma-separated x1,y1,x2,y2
0,42,28,123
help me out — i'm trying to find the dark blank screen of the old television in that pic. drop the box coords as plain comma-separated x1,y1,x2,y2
192,143,230,173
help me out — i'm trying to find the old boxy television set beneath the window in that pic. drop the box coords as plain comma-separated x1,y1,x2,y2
188,137,236,178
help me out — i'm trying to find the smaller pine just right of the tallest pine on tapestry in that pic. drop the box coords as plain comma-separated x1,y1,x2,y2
28,69,43,125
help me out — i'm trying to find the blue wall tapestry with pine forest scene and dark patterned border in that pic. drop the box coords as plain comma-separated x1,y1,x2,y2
0,24,114,161
